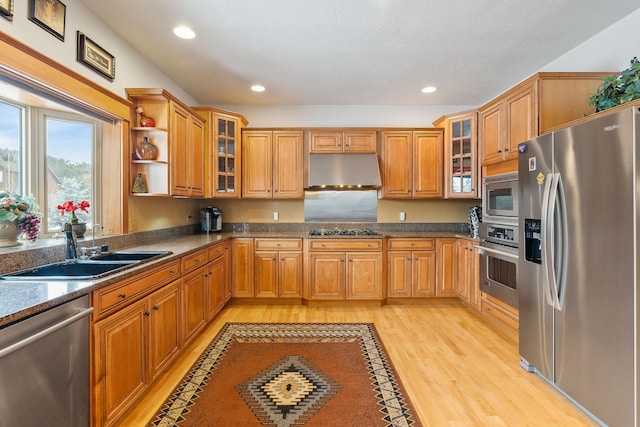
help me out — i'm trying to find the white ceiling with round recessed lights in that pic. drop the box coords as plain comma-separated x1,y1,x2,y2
81,0,640,105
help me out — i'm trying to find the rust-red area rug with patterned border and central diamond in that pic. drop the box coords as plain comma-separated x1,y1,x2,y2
149,323,421,427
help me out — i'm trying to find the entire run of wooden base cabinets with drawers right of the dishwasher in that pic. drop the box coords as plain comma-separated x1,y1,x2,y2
91,242,231,427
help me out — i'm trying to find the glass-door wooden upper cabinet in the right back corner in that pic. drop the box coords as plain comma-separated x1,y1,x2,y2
433,111,480,198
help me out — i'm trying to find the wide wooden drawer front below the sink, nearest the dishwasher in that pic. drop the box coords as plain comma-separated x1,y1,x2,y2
94,260,180,317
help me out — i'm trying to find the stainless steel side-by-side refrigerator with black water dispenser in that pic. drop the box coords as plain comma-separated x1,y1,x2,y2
517,108,640,427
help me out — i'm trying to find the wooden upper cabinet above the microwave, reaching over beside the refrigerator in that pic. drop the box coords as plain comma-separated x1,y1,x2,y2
479,73,611,166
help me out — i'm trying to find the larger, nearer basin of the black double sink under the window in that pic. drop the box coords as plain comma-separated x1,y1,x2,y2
0,261,138,281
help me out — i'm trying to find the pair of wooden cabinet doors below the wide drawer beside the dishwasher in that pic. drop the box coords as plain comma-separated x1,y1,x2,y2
92,274,182,426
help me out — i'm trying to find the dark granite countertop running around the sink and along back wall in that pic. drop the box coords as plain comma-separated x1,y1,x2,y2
0,231,478,328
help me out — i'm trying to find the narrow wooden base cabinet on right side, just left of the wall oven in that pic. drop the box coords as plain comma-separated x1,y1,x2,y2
456,239,480,311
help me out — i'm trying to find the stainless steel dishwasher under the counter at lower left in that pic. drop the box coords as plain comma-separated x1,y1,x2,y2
0,296,93,427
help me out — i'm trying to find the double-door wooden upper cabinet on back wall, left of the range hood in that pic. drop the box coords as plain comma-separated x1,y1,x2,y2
242,130,304,199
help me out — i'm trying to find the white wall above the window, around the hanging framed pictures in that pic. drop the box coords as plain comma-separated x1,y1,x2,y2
0,0,196,105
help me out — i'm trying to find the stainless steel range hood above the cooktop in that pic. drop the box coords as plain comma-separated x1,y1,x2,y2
306,153,382,190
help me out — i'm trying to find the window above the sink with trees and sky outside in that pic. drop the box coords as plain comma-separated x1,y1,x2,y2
0,95,101,236
